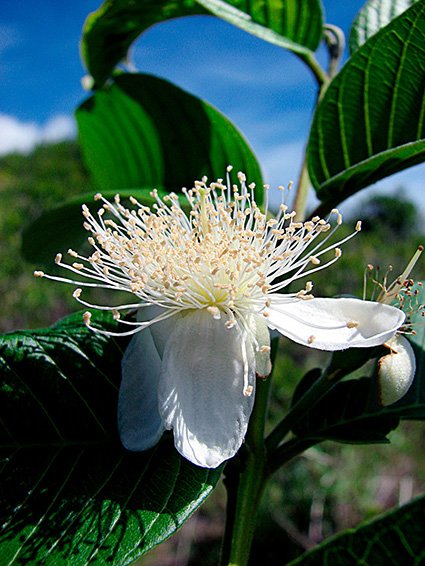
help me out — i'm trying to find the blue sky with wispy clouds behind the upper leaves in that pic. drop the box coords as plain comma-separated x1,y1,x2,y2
0,0,424,215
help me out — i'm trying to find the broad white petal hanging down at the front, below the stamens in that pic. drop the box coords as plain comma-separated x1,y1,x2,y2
159,309,255,468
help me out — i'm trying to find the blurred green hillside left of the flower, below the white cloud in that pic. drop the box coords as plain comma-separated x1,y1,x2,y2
0,142,94,332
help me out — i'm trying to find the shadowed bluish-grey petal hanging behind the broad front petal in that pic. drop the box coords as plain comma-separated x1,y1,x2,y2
118,327,165,451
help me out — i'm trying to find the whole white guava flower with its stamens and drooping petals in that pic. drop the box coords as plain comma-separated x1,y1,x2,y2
37,168,404,467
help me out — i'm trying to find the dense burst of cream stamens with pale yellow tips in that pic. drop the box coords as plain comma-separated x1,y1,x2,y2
35,167,360,334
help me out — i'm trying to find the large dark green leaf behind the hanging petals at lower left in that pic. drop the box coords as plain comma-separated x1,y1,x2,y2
0,313,221,566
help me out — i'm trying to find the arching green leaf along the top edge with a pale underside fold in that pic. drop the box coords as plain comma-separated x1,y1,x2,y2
81,0,323,87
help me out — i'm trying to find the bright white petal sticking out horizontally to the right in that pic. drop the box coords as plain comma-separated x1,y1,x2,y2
266,295,405,350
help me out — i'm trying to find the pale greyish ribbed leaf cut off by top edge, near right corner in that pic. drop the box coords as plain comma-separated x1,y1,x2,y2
349,0,416,53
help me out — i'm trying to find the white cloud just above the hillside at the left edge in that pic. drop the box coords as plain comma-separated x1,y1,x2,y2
0,114,76,155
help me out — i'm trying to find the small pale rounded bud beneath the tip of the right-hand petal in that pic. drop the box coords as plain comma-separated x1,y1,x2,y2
378,335,416,406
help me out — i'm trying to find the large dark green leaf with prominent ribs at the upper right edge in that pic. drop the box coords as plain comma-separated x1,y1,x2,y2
308,0,425,209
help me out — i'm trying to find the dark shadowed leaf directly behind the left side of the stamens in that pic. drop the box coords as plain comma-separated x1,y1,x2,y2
21,189,164,269
